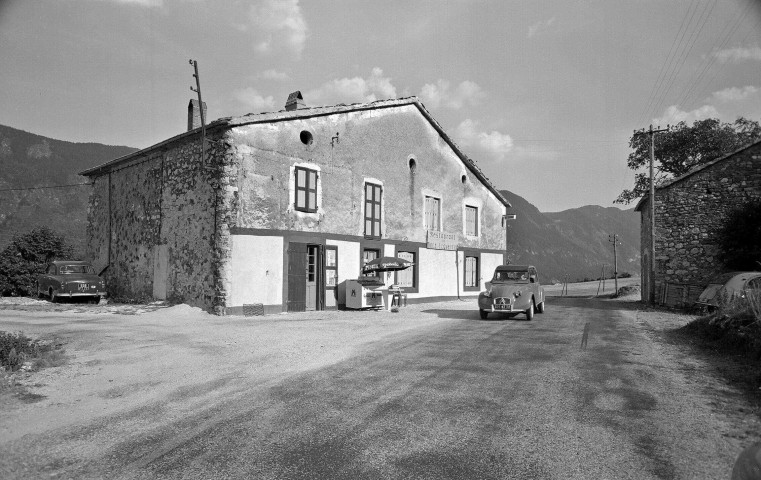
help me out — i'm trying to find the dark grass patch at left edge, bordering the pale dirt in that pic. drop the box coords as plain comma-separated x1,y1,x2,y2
0,331,67,409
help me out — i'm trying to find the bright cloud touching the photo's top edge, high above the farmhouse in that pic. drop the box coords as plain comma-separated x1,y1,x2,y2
249,0,307,56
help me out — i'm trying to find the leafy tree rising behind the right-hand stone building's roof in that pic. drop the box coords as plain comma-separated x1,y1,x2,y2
614,117,761,203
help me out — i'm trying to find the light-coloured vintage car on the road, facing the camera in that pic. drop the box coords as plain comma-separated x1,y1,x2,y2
478,265,544,320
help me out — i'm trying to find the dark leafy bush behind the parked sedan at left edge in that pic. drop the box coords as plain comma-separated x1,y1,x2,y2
0,227,74,296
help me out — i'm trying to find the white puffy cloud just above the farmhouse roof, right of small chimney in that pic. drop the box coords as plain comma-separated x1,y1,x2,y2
304,67,396,105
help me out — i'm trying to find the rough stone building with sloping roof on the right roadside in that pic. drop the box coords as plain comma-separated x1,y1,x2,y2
635,142,761,306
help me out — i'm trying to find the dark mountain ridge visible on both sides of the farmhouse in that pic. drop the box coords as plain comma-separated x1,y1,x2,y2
0,125,640,283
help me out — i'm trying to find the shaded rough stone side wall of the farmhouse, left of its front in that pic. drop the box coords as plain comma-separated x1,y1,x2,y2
88,136,229,311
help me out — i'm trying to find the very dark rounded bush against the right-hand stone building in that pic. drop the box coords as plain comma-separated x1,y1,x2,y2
718,199,761,271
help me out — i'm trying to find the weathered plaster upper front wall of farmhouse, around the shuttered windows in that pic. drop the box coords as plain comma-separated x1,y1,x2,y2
228,105,505,249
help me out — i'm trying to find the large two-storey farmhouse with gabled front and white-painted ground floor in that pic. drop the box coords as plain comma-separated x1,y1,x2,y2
82,92,510,315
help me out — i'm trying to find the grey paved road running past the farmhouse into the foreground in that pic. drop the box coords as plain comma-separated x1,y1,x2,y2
0,298,748,479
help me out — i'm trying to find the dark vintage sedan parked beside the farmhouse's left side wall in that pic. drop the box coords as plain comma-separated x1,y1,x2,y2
37,260,106,302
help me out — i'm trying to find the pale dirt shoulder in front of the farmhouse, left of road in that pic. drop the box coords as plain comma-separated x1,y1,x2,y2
0,302,444,442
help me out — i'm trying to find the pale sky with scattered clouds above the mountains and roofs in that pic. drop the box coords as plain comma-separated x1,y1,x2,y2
0,0,761,212
